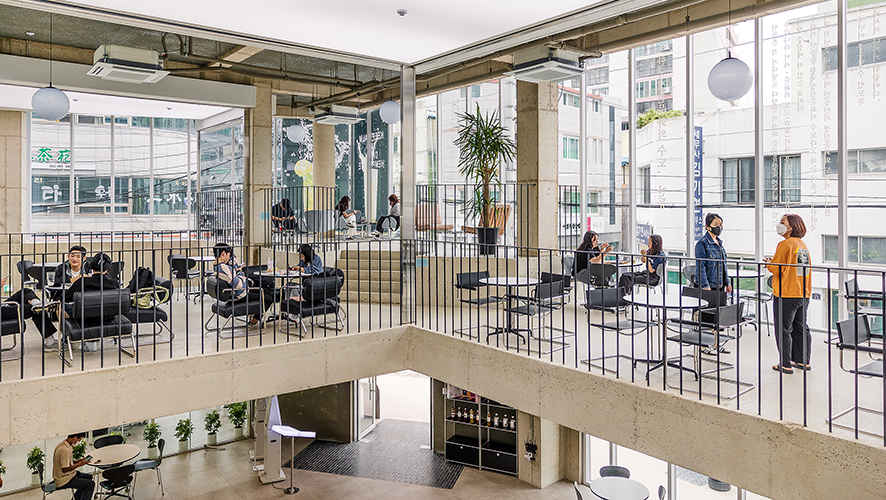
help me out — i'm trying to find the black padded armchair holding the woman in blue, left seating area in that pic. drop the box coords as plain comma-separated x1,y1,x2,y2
277,269,344,338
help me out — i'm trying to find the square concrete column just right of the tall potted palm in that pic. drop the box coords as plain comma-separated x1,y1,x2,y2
517,81,558,254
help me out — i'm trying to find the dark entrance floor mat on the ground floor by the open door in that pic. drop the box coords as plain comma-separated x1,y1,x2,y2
283,419,462,490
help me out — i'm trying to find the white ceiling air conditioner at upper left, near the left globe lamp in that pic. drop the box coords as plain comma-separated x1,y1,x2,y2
87,45,169,83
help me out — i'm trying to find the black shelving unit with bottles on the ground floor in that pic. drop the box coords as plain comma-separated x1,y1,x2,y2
445,398,517,476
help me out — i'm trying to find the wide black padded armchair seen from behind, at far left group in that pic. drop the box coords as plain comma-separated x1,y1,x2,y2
59,288,135,366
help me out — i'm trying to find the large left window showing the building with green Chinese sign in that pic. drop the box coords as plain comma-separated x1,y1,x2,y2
28,114,196,233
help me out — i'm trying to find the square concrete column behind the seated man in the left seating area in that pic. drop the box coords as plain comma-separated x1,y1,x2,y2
243,82,274,258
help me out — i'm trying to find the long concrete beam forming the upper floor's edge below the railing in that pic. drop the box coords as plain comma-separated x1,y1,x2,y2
0,327,886,500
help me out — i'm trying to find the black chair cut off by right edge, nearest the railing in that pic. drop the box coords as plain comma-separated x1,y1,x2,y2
825,314,886,438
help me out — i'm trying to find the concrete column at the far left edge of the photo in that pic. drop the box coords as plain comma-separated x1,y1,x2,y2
0,111,28,242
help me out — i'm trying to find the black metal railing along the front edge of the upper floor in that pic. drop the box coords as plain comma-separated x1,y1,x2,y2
0,233,886,445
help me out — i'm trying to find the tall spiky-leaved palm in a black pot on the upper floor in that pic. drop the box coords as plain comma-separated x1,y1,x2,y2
455,105,517,255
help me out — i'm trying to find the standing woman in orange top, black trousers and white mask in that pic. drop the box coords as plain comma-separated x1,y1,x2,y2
766,214,812,373
